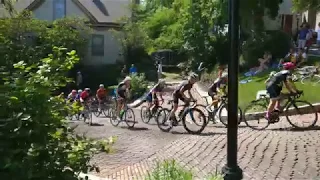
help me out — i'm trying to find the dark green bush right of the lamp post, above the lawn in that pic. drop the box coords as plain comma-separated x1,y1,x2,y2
242,31,292,68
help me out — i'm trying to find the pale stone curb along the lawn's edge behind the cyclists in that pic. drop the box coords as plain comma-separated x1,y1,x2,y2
194,84,320,119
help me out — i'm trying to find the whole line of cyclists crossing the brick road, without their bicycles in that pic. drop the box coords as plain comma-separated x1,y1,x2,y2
64,59,301,126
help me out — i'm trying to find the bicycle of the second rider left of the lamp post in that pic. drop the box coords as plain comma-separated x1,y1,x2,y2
156,100,207,134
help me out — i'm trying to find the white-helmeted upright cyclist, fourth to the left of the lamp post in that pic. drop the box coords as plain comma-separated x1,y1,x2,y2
116,76,131,118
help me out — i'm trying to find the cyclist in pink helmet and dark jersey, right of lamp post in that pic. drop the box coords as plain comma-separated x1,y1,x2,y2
266,62,301,120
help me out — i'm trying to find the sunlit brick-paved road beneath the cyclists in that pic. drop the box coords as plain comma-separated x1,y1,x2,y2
77,84,320,180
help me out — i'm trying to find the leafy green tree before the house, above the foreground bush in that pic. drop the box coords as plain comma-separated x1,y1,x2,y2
0,12,89,68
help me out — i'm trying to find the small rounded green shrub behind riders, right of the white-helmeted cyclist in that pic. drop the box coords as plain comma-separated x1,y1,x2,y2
131,74,148,99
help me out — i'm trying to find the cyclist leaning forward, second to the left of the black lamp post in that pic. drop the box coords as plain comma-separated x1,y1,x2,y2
169,73,198,126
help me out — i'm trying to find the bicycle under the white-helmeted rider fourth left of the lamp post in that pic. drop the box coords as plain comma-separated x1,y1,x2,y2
110,98,136,128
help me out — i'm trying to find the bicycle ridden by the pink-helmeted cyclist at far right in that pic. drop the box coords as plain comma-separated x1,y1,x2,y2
243,92,318,130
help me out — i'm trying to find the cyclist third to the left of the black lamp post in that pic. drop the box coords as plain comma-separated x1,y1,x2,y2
147,79,165,114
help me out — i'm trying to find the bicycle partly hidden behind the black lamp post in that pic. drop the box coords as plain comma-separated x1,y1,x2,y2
197,96,242,127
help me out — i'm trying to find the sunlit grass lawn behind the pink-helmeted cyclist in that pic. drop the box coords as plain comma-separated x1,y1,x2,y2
239,68,320,108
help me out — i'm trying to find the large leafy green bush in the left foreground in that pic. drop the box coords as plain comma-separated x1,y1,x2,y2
0,47,114,180
